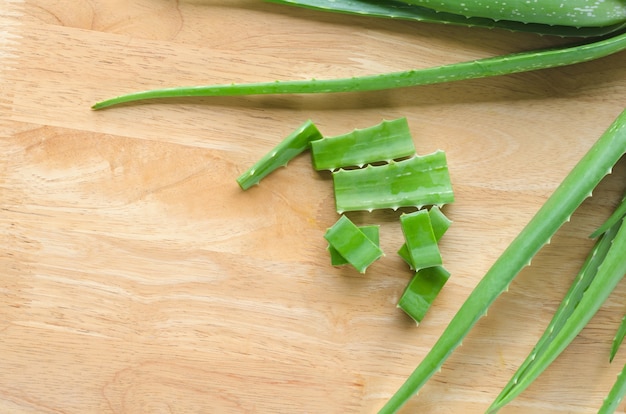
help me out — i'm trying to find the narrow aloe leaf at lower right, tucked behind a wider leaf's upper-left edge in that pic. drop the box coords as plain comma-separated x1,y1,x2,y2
496,215,621,410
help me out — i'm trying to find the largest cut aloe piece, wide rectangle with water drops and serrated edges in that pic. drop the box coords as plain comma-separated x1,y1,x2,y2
333,151,454,214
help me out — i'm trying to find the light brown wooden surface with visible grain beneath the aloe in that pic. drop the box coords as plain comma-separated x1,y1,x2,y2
0,0,626,414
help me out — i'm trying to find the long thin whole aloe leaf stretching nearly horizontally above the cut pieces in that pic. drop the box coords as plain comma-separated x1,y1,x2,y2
92,33,626,110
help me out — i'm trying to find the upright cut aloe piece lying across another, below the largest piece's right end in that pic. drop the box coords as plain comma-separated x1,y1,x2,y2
400,210,443,271
